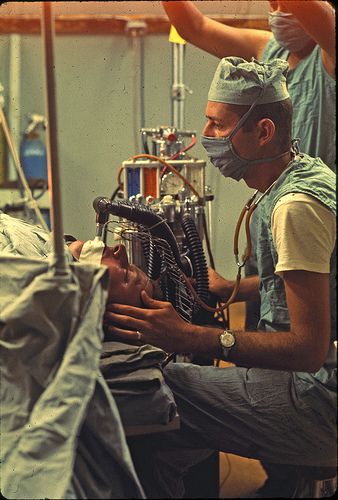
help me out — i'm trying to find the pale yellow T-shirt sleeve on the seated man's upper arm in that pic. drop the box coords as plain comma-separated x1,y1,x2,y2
271,193,336,274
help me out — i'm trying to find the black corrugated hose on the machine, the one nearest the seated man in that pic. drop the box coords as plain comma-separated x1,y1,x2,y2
182,214,209,313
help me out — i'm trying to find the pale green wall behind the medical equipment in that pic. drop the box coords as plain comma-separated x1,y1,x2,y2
0,2,267,277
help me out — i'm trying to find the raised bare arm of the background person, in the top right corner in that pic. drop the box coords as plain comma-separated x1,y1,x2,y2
276,0,336,77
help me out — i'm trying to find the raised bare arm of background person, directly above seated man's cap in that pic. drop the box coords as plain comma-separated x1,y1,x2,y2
162,1,272,60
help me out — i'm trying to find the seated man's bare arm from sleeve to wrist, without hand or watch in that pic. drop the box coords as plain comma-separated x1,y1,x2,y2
190,271,330,372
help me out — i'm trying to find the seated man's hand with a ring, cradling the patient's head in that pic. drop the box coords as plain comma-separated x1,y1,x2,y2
105,290,192,352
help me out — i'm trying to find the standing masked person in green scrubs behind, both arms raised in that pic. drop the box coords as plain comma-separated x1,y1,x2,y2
162,0,336,362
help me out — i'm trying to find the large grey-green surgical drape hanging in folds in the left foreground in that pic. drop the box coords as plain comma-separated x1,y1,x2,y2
0,255,144,499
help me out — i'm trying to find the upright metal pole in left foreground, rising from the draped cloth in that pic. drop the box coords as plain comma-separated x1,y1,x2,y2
42,2,68,274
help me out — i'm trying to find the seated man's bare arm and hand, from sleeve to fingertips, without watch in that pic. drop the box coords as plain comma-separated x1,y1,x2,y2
106,271,330,372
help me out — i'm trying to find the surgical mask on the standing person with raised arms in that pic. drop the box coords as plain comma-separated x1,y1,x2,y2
269,10,312,52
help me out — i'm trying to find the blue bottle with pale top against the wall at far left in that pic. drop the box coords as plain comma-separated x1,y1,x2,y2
20,114,48,187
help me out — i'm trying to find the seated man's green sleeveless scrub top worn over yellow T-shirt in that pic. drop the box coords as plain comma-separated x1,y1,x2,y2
257,154,336,389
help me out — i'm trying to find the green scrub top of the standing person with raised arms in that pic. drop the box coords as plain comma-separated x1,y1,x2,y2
262,37,336,171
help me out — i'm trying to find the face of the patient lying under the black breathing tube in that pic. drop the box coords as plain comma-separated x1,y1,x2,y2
69,240,153,307
